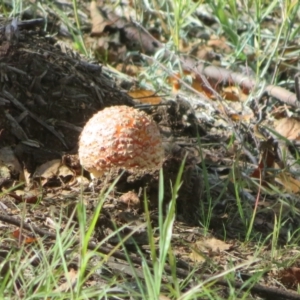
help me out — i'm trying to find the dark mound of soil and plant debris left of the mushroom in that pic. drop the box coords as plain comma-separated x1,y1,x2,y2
0,20,133,166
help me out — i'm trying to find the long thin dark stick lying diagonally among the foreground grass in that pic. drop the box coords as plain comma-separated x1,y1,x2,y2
0,214,300,300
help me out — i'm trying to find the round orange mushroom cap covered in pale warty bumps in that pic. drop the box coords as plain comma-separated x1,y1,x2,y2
79,105,164,178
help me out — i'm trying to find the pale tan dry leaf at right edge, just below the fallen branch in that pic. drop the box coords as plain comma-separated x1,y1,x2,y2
275,118,300,140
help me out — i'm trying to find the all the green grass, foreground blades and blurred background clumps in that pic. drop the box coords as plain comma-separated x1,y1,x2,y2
0,0,300,300
